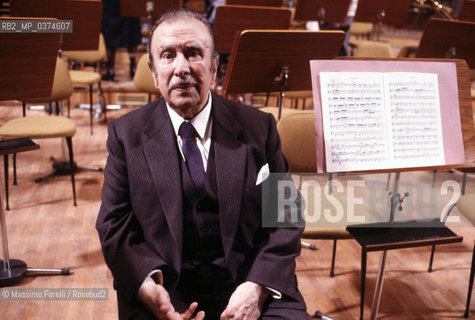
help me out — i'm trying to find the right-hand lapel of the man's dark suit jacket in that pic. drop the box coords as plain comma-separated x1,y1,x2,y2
212,96,247,257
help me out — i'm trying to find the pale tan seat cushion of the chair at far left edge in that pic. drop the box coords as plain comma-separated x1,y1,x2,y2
0,116,76,139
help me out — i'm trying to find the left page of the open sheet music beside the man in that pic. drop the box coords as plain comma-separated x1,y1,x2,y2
320,72,388,171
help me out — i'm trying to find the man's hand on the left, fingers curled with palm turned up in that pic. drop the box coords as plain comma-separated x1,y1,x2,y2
139,278,205,320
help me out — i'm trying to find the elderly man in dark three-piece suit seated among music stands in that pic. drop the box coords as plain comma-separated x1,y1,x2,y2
97,10,310,320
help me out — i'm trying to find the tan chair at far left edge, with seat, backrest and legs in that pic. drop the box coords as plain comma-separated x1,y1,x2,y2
0,58,77,206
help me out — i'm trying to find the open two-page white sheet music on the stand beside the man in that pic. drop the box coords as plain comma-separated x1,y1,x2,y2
320,72,444,172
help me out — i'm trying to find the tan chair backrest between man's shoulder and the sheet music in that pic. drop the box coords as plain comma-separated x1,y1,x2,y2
277,111,317,173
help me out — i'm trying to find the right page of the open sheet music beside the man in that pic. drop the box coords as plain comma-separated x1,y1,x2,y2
384,72,445,167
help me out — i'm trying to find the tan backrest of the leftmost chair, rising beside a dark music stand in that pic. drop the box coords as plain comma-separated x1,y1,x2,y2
28,58,74,102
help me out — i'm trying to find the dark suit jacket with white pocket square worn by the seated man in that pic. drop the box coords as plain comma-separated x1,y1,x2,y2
96,95,303,314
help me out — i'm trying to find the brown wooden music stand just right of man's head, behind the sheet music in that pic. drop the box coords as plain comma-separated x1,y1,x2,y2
223,30,345,119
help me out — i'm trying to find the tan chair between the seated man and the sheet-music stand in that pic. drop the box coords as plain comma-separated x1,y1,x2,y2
277,109,369,277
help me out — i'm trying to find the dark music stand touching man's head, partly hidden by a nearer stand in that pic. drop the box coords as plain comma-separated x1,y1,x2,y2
214,5,292,54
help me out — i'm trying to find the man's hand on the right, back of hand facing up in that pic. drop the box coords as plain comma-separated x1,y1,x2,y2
221,281,269,320
